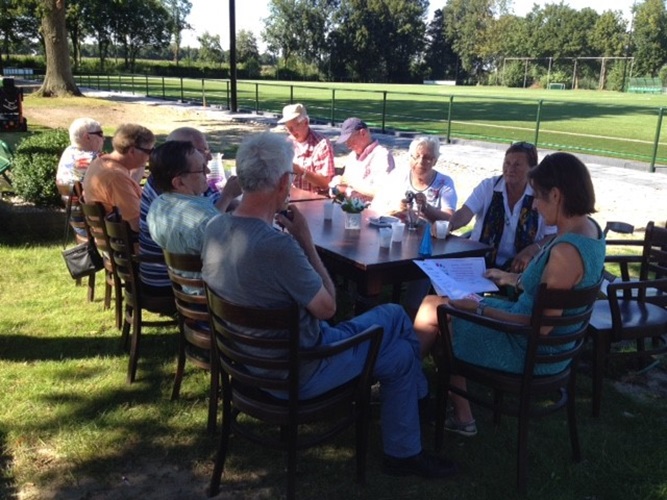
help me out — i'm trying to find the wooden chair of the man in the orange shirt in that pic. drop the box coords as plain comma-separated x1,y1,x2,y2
81,202,122,330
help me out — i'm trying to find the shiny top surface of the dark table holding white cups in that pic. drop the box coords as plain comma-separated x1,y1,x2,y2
297,200,489,270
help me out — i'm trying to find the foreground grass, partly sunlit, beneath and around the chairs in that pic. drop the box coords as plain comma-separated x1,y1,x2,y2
0,231,667,499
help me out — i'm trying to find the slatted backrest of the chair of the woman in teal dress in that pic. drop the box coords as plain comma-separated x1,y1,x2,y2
524,281,601,379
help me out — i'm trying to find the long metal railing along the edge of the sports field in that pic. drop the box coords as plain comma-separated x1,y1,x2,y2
75,74,667,172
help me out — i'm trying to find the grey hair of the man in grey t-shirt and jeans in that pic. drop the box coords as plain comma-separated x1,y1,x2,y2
236,132,294,192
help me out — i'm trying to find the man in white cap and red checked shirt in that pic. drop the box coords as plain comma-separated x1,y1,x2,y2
278,103,334,192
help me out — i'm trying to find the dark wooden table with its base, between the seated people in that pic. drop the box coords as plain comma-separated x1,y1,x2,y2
296,200,489,312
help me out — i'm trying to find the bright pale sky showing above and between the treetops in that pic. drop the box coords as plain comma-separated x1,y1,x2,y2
183,0,634,50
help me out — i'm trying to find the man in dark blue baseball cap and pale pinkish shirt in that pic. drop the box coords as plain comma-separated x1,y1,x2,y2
332,117,394,200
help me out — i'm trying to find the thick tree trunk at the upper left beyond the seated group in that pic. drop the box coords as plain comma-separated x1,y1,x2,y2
37,0,82,97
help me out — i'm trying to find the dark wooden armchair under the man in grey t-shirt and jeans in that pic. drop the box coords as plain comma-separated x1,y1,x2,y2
206,287,382,499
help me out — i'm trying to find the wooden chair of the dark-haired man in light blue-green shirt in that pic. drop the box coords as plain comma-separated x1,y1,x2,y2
164,250,220,433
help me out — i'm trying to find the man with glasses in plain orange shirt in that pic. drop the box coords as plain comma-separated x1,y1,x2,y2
83,123,155,233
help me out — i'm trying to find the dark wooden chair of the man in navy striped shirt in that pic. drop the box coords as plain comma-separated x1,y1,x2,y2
104,214,178,384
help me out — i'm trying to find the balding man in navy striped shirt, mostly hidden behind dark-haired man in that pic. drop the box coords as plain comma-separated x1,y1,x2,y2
139,127,241,295
